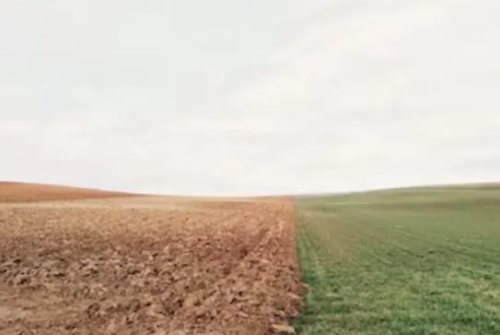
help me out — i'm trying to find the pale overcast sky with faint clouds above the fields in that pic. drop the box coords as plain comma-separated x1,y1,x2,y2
0,0,500,195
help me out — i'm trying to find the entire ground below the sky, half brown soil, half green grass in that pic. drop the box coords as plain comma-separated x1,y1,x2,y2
4,183,500,335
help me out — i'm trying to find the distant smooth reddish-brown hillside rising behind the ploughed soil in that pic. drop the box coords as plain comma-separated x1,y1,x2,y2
0,181,136,203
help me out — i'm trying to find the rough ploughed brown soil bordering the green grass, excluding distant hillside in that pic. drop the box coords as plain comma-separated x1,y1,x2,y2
0,185,303,335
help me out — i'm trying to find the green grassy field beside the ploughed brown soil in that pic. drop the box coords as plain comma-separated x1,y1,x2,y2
295,187,500,335
